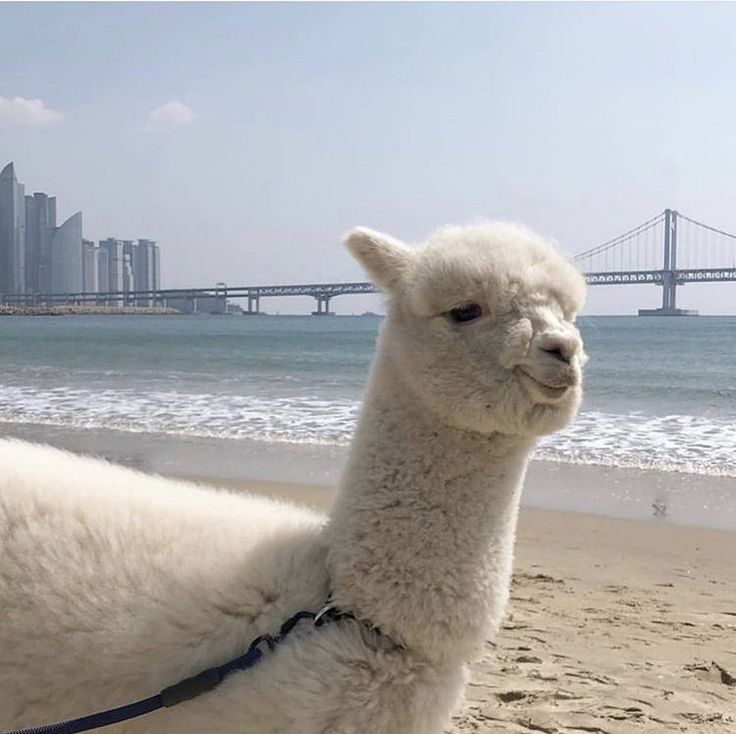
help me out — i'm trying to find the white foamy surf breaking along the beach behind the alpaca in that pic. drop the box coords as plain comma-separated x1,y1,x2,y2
0,385,736,476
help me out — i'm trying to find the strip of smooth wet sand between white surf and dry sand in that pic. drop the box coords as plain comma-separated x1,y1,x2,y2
0,423,736,531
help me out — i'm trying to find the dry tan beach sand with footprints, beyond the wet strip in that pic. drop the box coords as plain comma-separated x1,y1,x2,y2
185,482,736,734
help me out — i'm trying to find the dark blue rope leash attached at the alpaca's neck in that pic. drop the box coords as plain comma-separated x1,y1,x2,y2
5,603,355,734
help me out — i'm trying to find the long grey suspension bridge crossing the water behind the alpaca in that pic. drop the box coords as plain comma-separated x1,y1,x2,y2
0,209,736,316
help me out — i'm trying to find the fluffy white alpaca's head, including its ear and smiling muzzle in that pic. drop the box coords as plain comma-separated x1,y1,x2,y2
345,218,586,436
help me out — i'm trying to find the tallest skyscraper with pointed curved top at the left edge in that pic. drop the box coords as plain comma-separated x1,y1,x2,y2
0,163,26,295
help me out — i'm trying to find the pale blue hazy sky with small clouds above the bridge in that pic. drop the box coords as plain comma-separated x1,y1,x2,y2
0,3,736,314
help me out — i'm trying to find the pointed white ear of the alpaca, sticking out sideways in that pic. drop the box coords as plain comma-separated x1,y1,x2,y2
343,227,414,291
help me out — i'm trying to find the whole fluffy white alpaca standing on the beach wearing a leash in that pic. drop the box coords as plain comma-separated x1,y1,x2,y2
0,224,585,734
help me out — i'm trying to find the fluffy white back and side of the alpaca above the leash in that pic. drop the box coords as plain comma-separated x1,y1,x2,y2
0,440,327,730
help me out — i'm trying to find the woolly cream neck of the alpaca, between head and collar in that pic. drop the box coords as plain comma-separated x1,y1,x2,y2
329,352,531,659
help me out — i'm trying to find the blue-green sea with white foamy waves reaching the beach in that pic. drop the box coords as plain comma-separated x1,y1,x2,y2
0,316,736,528
